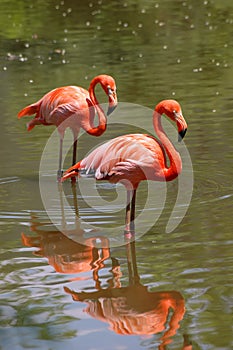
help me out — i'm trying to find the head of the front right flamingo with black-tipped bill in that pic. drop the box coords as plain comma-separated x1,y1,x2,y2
155,100,187,141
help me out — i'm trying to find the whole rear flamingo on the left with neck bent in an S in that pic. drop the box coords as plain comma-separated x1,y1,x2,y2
18,74,117,179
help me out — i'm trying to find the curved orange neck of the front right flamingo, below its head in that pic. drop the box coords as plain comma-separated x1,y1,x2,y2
153,110,182,181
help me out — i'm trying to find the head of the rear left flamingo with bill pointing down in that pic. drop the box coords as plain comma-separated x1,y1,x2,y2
100,74,117,115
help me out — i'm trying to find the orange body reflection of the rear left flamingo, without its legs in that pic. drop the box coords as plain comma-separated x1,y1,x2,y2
22,222,110,281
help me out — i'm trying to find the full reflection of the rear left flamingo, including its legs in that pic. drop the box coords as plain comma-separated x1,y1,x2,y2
22,183,110,288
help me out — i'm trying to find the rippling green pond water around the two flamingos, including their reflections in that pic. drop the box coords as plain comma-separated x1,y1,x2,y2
0,0,233,350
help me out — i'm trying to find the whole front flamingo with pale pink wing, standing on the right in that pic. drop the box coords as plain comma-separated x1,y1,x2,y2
61,100,187,235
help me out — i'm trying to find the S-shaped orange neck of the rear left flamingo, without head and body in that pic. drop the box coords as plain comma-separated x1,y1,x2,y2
87,77,107,136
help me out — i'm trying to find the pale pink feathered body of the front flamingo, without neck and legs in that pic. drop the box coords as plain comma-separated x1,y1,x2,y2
72,134,166,189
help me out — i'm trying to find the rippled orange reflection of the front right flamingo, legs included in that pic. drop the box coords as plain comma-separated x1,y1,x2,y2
64,242,192,350
